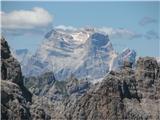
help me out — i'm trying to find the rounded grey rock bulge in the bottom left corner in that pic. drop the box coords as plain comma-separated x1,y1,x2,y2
1,80,31,120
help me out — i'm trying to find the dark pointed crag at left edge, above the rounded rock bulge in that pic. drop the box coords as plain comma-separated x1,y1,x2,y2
1,38,23,85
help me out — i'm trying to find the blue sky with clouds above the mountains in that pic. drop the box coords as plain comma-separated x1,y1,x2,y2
1,1,160,57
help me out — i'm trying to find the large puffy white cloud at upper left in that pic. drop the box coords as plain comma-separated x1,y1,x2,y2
0,7,52,29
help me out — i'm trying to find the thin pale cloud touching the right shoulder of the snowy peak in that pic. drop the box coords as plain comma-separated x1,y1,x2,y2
99,27,141,39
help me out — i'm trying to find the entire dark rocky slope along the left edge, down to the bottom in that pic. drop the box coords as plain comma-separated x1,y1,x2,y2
1,37,49,120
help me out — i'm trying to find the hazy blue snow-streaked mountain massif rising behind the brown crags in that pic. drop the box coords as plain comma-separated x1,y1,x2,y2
14,28,136,80
